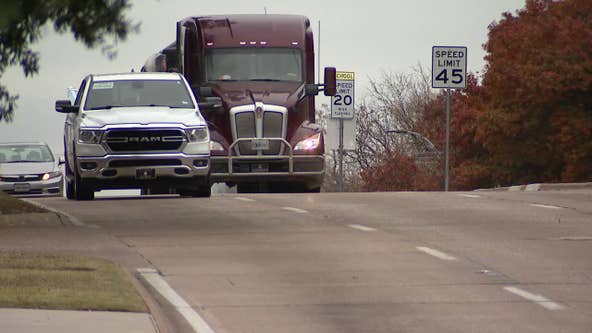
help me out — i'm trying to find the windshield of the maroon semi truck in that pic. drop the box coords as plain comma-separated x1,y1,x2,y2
205,47,303,82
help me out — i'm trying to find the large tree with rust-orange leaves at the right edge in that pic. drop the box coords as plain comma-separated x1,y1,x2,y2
475,0,592,185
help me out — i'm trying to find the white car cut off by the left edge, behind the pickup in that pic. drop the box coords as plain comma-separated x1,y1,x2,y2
0,142,64,196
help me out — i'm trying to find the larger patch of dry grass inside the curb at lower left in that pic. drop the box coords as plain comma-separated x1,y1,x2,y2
0,251,147,312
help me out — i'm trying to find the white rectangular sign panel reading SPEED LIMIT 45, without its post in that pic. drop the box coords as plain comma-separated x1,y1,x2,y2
432,46,467,89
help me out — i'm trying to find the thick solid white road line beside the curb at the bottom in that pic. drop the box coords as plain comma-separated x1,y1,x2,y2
137,268,214,333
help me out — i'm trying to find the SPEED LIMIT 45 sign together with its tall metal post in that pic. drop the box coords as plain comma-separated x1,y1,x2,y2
432,46,467,192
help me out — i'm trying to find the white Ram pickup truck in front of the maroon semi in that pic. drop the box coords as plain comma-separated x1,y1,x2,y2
55,73,211,200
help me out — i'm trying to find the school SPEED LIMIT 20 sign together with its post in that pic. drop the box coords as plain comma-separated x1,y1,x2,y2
331,72,354,192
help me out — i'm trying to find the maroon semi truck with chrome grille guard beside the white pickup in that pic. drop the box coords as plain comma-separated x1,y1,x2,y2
143,15,335,192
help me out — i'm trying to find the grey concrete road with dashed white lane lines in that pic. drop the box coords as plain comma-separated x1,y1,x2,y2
36,190,592,333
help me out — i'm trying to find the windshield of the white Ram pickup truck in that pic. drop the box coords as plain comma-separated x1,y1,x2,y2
84,80,194,110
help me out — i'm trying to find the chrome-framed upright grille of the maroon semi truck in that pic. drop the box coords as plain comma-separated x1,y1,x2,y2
231,103,287,155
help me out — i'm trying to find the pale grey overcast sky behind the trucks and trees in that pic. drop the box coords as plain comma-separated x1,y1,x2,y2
0,0,524,154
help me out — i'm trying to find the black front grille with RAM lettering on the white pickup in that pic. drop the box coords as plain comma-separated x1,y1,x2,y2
105,129,185,152
